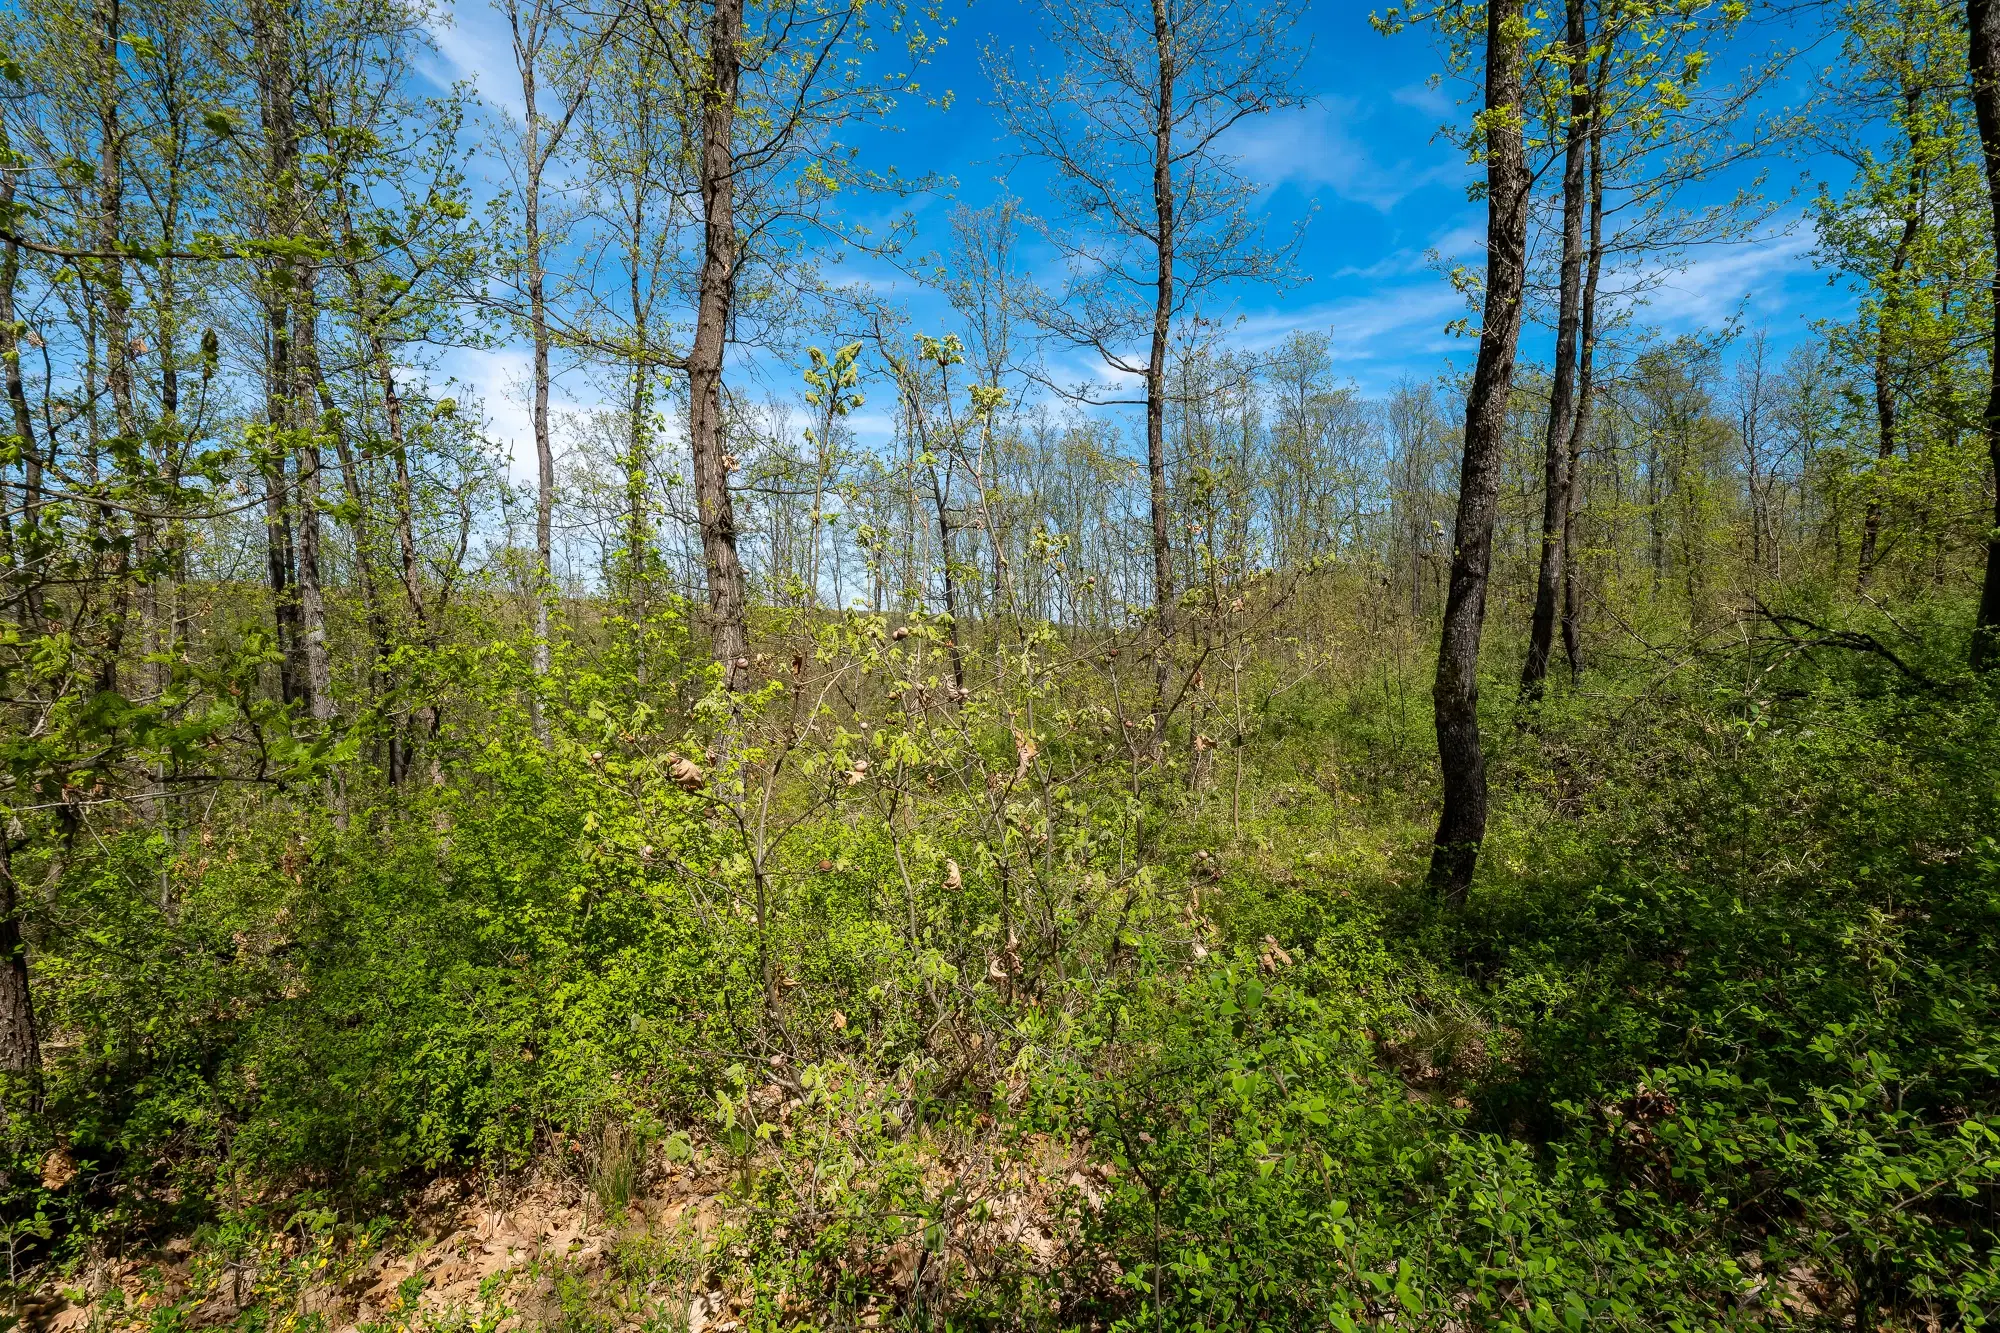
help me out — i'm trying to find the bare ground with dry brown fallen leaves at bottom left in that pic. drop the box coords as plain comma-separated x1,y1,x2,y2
26,1120,1108,1333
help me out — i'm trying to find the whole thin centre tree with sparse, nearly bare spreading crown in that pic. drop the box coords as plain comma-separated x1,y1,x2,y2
984,0,1304,749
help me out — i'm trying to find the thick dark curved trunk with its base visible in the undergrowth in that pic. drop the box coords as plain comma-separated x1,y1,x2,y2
1430,0,1530,903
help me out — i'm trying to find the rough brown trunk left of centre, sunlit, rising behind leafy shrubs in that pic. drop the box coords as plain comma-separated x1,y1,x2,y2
688,0,748,691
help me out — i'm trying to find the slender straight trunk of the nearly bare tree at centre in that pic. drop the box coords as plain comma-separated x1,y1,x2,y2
1146,0,1180,755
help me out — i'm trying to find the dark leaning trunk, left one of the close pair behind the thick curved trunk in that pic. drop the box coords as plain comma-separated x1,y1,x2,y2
1520,0,1590,703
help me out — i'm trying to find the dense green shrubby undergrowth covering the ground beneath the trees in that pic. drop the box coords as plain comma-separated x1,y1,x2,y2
6,592,2000,1329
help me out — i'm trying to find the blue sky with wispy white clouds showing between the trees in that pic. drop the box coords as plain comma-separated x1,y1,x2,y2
418,0,1846,472
